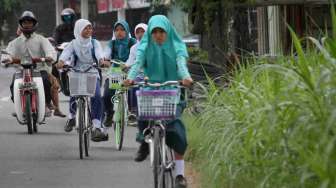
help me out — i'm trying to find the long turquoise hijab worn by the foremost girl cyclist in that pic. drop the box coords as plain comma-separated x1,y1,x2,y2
136,15,188,82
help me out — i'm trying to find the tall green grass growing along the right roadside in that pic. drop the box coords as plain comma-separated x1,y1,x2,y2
188,5,336,188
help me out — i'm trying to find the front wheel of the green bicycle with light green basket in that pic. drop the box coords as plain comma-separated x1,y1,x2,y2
114,94,126,151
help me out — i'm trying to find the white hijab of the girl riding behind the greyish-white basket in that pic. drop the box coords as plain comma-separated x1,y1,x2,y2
73,19,92,62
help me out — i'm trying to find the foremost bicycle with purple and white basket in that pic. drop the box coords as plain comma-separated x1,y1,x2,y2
135,81,182,188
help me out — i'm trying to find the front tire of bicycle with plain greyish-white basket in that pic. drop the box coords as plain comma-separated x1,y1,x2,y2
77,99,85,159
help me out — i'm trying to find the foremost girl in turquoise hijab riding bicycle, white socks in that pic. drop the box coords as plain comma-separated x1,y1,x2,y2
124,15,193,187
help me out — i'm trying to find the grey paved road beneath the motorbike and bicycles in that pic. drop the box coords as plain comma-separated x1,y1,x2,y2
0,68,152,188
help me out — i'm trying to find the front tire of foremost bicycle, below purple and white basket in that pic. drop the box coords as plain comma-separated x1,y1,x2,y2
153,127,162,188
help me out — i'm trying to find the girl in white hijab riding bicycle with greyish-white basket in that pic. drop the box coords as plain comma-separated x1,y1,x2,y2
57,19,110,142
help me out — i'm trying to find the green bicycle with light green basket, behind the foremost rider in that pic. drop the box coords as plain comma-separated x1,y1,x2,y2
103,60,129,151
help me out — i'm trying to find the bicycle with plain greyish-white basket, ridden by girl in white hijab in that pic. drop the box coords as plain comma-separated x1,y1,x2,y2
65,65,97,159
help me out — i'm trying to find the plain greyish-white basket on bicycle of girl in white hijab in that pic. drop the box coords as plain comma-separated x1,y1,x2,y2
69,72,97,97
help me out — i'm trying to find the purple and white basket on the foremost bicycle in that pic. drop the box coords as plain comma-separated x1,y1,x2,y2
136,90,179,120
